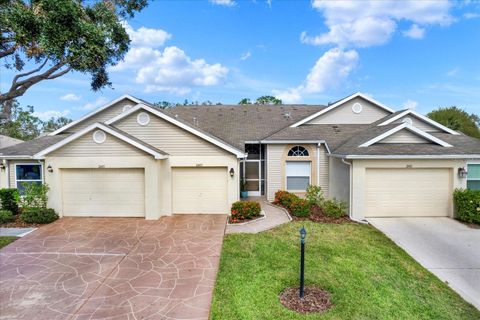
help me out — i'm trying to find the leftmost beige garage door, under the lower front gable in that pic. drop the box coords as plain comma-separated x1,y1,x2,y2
62,169,145,217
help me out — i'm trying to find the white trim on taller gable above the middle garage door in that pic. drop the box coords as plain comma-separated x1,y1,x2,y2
105,103,246,158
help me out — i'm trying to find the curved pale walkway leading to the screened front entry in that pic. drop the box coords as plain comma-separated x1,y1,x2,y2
225,197,291,234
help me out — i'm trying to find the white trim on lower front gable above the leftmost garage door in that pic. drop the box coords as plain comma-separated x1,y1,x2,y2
33,122,168,159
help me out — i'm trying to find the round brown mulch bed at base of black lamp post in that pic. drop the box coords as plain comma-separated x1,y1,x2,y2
279,286,332,314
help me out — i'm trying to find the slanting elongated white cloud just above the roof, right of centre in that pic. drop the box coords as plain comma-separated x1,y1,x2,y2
273,48,359,103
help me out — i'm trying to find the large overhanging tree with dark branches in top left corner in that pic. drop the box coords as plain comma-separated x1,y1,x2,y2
0,0,147,117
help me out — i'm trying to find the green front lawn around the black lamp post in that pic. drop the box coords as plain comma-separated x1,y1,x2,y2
211,222,480,320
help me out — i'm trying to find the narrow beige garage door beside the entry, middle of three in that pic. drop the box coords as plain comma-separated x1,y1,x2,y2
172,168,229,214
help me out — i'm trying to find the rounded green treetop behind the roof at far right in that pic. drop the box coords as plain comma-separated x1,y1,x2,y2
427,106,480,139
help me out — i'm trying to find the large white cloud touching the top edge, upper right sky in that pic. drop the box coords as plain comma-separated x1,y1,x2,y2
301,0,454,47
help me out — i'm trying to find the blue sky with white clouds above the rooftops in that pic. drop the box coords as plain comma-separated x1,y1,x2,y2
0,0,480,119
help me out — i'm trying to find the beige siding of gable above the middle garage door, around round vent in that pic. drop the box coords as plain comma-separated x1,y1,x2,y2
114,112,227,156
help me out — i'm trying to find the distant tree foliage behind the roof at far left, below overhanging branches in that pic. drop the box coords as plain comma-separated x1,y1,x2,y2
0,101,72,141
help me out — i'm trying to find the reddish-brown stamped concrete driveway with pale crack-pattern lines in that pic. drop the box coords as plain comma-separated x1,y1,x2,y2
0,215,226,320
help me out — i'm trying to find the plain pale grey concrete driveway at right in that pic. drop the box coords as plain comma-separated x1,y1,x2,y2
368,218,480,309
